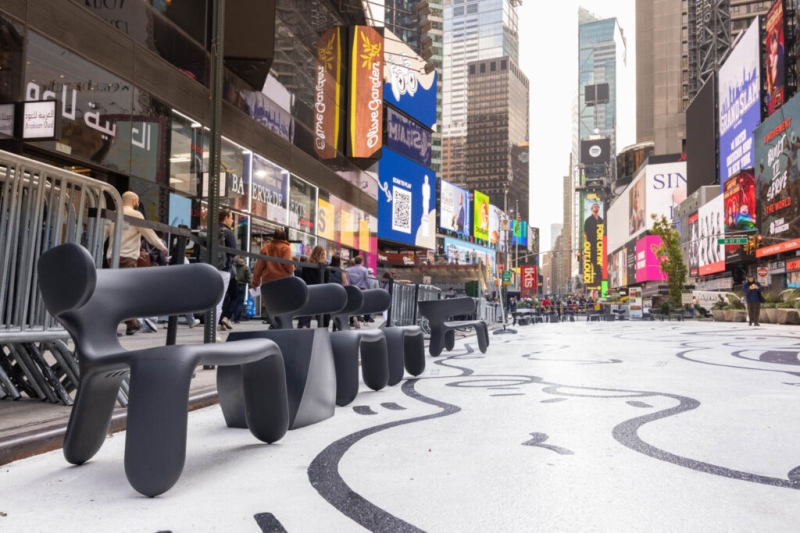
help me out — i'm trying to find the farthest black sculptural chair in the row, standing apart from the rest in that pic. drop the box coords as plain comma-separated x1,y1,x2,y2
419,297,489,357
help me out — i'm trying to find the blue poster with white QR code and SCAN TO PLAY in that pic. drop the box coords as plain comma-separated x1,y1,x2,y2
378,149,436,249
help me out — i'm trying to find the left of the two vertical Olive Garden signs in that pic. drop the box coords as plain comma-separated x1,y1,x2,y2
314,28,342,159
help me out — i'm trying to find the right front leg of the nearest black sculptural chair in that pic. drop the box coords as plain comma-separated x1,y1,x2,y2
241,353,289,444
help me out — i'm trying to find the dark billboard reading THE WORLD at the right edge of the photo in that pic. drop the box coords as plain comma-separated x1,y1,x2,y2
755,92,800,257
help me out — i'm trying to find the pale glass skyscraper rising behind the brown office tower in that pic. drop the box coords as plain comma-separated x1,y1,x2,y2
442,0,521,184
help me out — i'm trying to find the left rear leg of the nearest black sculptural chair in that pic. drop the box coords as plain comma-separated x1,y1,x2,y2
64,370,127,465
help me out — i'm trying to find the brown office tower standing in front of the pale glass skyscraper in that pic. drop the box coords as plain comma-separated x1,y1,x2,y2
460,57,529,221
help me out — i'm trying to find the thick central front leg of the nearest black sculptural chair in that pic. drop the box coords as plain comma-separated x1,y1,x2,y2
125,357,196,498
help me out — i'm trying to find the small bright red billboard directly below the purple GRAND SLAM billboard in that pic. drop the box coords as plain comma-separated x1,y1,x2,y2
725,170,756,264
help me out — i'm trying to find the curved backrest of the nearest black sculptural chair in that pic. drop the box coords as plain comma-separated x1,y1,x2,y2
37,243,224,360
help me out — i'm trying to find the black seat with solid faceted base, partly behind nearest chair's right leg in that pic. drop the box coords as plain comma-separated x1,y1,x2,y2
217,276,347,429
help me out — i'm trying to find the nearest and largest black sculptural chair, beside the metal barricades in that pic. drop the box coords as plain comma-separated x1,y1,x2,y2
38,243,289,497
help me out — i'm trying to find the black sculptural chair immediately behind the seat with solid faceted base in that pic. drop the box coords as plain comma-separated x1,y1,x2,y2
331,285,391,407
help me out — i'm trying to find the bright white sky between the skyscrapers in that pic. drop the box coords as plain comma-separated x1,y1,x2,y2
518,0,636,252
